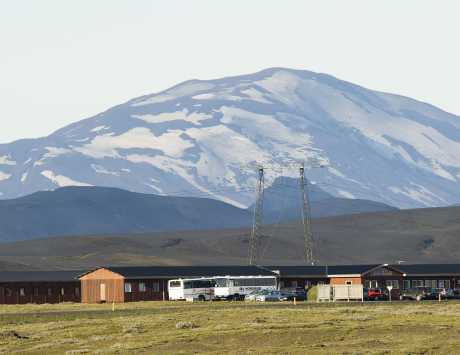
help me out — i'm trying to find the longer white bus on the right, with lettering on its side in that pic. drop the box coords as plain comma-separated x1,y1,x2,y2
214,276,278,300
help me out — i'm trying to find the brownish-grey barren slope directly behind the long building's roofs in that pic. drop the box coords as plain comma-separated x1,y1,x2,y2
0,207,460,269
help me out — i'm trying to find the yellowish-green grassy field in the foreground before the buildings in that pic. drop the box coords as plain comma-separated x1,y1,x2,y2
0,302,460,354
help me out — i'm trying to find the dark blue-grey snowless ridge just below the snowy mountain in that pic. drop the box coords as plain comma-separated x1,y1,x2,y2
0,184,393,241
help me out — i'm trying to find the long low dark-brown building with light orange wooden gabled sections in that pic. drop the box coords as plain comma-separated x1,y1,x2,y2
0,264,460,304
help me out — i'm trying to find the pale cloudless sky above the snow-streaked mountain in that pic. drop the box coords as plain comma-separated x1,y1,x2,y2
0,0,460,143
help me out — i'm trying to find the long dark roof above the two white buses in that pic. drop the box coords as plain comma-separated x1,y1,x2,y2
95,266,274,279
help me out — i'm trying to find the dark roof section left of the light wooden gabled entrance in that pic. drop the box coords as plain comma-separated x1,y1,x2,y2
0,270,84,282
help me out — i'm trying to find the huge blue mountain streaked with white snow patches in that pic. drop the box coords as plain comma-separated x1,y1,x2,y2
0,68,460,208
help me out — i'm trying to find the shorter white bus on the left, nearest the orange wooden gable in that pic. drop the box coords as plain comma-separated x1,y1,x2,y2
168,277,215,301
